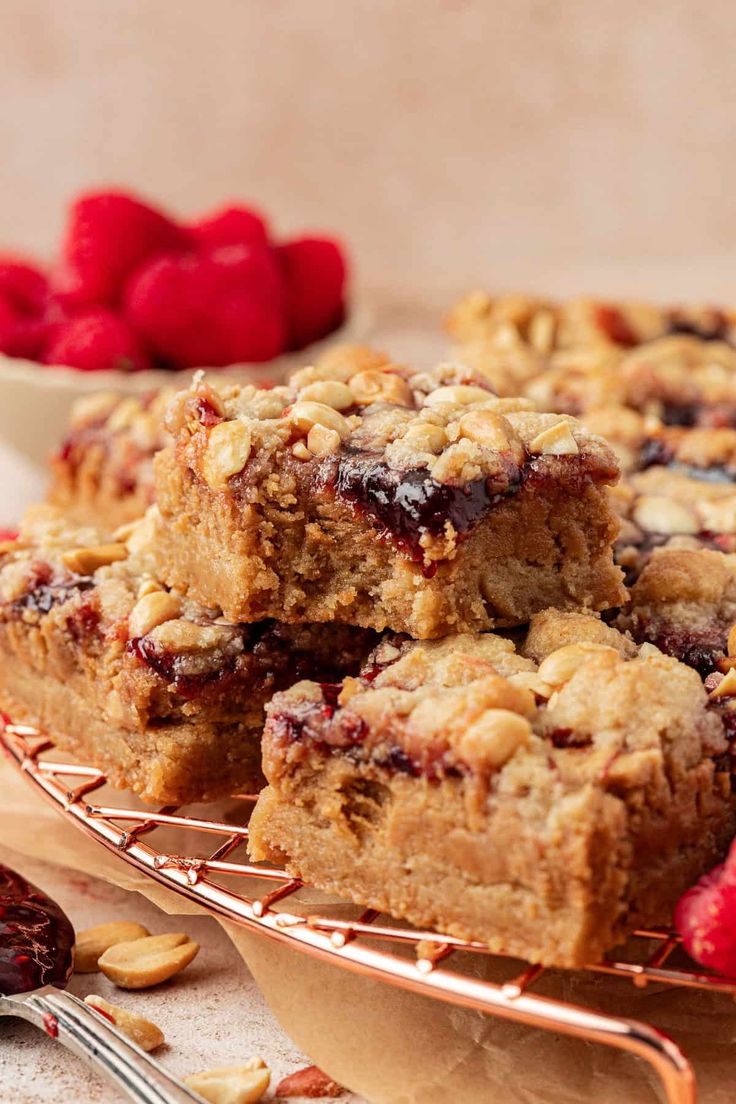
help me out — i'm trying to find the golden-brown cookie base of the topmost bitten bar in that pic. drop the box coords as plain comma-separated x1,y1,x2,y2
156,449,625,639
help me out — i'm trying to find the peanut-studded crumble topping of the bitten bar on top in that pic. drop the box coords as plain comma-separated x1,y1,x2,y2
169,361,617,499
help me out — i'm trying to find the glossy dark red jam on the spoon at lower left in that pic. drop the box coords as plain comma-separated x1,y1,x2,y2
0,864,74,1002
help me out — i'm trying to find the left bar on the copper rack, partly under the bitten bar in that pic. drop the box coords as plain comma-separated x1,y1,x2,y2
0,508,374,804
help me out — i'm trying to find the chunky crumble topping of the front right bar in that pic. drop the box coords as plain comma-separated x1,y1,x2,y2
266,611,726,788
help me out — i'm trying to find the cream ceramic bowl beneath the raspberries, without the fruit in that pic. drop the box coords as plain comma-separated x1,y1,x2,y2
0,304,371,466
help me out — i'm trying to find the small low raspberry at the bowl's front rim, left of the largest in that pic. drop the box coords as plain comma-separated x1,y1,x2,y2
43,308,150,372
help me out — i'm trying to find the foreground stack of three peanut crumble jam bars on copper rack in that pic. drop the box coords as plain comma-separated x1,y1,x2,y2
0,351,735,966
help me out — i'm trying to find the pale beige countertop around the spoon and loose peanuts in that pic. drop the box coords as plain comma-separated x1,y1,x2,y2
0,853,361,1104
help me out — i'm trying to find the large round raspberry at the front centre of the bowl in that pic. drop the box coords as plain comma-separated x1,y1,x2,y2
126,245,286,368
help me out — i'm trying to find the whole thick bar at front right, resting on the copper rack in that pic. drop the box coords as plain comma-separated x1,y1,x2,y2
250,612,736,966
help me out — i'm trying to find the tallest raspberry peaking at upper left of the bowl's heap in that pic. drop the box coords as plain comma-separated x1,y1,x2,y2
54,192,190,309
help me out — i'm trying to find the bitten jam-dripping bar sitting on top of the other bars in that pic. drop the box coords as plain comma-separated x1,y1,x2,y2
154,354,623,638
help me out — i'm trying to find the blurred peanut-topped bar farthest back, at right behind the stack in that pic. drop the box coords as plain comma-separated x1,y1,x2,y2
448,293,736,427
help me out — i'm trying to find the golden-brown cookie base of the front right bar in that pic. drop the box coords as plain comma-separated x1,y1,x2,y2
249,756,735,967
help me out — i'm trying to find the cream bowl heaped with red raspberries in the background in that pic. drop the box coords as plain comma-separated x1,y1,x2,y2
0,190,365,463
